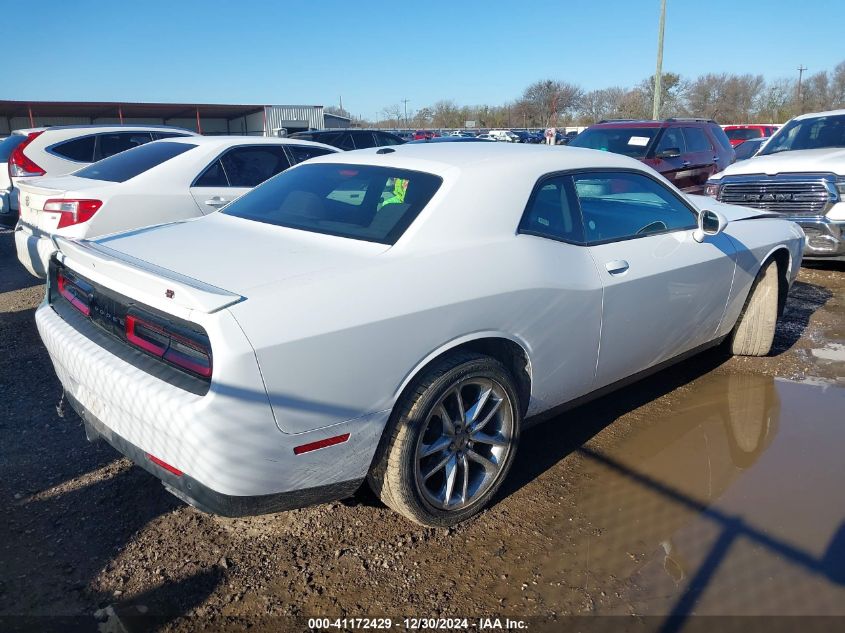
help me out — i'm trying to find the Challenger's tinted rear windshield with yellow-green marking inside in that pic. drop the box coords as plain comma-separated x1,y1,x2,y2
221,163,443,244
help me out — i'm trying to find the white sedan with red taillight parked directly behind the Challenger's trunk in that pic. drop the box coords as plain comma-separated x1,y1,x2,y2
15,136,338,278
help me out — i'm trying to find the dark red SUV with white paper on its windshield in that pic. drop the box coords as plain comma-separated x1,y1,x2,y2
569,119,736,194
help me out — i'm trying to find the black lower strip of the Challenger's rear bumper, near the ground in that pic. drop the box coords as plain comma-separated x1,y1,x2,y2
65,392,364,517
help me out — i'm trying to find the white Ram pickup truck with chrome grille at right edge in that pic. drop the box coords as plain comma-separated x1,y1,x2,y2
705,110,845,261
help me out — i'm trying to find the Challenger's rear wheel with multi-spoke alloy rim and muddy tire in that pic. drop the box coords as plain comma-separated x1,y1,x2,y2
369,353,520,527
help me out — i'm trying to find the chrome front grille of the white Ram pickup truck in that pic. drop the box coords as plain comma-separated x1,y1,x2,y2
718,176,836,216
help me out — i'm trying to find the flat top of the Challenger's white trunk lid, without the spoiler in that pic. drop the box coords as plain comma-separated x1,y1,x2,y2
95,213,389,296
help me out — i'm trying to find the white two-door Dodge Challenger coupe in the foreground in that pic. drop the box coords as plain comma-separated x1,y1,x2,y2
36,143,804,526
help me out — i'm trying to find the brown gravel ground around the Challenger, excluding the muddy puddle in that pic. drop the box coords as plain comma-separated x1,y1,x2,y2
0,225,845,630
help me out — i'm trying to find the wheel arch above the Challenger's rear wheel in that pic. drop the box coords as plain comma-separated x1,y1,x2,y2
393,331,532,415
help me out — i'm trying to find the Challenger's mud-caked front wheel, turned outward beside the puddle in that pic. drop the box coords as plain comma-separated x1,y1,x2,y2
731,260,778,356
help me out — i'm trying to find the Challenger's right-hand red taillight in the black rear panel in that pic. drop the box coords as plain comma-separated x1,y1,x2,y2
125,314,211,378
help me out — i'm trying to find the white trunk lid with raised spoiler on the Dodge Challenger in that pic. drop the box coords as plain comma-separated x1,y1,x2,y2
56,213,388,312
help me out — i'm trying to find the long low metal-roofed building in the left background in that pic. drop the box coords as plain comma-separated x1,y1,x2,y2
0,101,351,136
